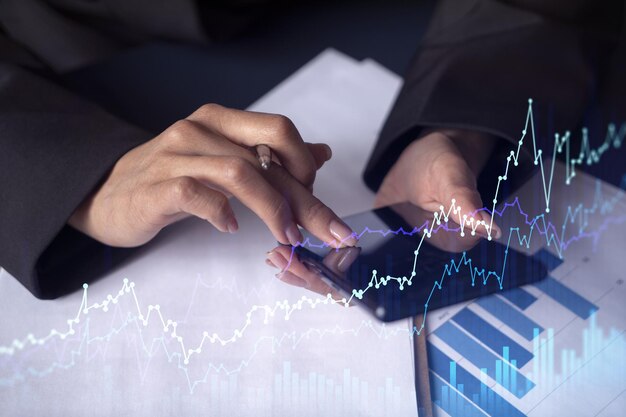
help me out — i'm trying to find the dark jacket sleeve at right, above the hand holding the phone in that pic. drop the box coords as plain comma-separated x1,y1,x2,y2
364,0,626,190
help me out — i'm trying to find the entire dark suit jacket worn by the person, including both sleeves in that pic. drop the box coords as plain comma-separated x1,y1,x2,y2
0,0,626,298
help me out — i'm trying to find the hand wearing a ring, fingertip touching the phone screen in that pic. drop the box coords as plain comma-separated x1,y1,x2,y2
68,104,355,247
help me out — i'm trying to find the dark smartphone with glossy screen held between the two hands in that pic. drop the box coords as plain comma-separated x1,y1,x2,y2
294,203,548,322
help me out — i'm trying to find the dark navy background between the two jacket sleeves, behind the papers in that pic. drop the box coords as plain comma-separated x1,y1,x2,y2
63,0,434,133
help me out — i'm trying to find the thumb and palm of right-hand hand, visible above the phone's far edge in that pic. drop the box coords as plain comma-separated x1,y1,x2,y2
374,129,501,239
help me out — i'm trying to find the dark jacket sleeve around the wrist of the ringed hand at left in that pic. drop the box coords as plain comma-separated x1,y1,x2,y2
0,63,150,298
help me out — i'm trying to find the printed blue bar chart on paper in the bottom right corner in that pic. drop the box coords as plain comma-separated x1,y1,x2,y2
428,248,626,417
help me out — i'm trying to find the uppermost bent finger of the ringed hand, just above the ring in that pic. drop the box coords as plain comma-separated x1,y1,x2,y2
188,104,317,187
